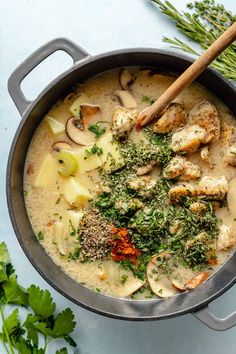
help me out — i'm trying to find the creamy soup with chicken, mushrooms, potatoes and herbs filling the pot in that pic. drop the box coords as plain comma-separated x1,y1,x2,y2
24,68,236,299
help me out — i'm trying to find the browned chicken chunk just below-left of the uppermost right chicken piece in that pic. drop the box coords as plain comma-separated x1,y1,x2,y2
171,124,207,153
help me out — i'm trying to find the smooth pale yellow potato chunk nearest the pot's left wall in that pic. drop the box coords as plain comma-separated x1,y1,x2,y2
34,154,59,187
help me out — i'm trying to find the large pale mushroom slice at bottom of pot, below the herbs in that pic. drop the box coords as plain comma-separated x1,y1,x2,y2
147,253,178,298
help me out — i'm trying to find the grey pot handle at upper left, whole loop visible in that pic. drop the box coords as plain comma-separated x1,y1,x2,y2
8,38,89,116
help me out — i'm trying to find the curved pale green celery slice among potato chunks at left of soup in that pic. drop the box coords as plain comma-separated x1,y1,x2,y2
56,150,78,177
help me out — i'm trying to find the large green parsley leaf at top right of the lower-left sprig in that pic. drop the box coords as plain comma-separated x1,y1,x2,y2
28,285,56,319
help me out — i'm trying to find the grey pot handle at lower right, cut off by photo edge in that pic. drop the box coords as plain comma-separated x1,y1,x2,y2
192,306,236,331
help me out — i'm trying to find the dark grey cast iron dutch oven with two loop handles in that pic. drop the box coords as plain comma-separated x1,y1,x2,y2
7,38,236,330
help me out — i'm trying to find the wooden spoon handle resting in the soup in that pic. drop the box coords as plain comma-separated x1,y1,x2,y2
136,22,236,127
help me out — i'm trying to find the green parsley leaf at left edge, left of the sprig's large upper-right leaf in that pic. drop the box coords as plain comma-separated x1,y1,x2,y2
2,274,28,306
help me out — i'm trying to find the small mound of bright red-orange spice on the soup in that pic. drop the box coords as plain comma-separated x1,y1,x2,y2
110,227,140,263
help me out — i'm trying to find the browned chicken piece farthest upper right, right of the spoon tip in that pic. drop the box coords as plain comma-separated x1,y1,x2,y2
187,100,220,144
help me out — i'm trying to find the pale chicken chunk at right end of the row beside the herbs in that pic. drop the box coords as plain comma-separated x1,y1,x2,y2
197,176,229,199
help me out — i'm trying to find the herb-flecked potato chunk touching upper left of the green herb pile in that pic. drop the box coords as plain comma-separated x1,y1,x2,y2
97,133,124,173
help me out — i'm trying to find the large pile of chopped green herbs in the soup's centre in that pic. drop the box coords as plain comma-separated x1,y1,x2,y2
95,128,218,279
